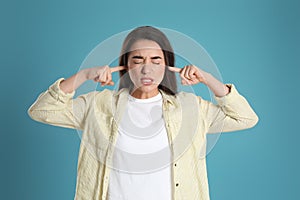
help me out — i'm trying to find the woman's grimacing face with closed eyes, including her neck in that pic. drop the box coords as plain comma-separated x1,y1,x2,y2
128,40,165,99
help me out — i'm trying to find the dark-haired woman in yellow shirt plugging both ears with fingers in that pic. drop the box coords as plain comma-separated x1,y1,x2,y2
28,26,258,200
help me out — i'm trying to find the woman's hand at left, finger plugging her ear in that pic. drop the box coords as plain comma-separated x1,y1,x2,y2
84,65,126,86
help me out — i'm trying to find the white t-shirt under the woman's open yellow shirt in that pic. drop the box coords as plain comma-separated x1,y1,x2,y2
108,93,171,200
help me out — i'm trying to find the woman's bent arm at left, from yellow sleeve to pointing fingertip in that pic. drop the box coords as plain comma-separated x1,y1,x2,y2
28,66,124,129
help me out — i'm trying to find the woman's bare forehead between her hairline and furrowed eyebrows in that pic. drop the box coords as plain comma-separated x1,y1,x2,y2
130,40,163,56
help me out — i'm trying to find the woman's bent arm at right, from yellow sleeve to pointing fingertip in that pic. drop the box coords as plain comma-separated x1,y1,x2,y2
169,65,258,133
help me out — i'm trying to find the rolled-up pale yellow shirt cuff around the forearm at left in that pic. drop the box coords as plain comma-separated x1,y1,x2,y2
48,78,75,103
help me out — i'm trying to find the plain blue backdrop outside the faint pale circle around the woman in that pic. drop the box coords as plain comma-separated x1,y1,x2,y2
0,0,300,200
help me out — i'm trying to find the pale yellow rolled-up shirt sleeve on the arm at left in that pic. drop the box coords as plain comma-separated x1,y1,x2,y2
28,78,91,130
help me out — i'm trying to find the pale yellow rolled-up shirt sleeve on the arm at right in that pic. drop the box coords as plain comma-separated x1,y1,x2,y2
200,84,258,133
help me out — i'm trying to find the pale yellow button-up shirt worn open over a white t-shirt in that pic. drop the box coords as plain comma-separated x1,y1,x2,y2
28,78,258,200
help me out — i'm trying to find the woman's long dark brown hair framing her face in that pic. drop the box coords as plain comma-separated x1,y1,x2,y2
119,26,177,95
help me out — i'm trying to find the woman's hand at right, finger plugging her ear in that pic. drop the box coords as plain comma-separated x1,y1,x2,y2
169,65,208,85
